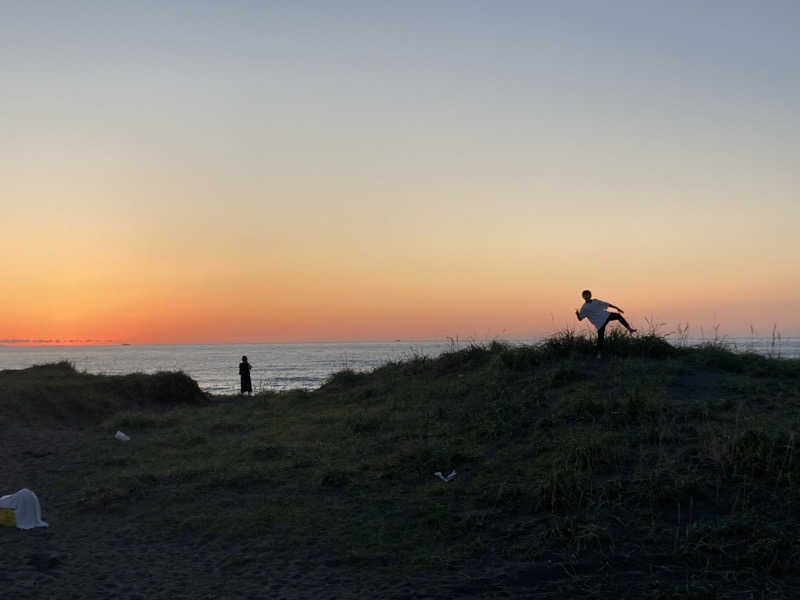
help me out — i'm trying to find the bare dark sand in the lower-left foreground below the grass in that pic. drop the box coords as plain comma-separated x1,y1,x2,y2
0,427,535,600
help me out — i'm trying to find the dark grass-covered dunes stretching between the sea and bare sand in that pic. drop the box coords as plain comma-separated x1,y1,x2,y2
0,334,800,597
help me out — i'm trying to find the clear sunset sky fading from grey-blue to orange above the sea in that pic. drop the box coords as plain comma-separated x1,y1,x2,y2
0,0,800,343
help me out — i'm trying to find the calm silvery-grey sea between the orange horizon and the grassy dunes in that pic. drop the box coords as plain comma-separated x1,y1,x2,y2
0,337,800,394
